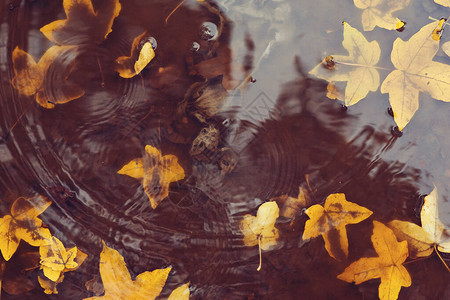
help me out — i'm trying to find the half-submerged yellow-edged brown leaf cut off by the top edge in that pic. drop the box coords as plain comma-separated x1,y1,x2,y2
41,0,121,45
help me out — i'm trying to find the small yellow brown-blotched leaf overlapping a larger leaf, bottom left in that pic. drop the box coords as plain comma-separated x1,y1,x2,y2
39,237,87,282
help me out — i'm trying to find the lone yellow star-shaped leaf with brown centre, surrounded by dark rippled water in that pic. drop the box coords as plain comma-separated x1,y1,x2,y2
117,145,184,209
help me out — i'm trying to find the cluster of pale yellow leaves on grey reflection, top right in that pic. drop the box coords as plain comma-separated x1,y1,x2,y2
310,0,450,130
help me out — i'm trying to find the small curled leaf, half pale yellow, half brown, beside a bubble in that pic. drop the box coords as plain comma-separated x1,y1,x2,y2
115,32,155,78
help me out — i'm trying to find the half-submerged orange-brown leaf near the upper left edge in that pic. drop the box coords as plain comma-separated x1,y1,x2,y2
11,46,84,108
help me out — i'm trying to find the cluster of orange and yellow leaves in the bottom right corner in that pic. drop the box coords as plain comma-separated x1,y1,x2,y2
240,188,450,299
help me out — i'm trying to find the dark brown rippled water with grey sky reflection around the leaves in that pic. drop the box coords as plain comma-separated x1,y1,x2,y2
0,0,450,299
